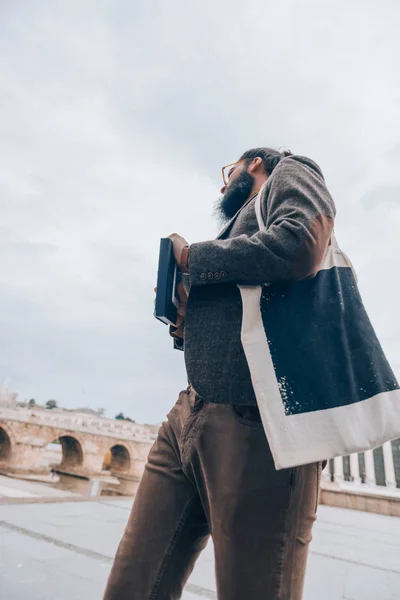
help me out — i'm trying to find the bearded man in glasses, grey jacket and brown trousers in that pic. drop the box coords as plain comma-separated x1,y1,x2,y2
105,148,335,600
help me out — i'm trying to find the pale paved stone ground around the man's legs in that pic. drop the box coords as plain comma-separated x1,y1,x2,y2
0,498,400,600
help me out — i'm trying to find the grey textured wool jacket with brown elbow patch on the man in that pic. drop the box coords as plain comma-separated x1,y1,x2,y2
185,156,335,404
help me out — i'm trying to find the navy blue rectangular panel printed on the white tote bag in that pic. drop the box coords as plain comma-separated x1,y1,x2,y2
261,267,399,415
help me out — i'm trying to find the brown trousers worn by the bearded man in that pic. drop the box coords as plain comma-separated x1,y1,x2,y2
104,389,321,600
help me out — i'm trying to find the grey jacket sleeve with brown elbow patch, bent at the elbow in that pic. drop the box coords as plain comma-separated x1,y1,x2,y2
189,157,335,285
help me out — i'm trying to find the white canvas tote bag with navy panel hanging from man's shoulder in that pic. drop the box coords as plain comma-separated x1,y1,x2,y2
238,190,400,469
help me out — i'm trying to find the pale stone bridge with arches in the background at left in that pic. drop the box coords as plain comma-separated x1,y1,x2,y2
0,408,156,479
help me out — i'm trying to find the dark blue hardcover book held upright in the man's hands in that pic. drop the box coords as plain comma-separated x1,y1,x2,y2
154,238,181,326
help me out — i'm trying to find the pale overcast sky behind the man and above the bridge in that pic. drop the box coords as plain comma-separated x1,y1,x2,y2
0,0,400,422
